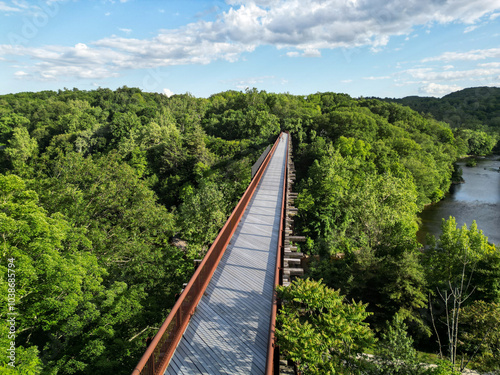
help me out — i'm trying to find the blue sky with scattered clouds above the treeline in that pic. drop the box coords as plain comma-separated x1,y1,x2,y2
0,0,500,97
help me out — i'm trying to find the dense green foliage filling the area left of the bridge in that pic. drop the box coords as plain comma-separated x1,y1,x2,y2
0,87,293,374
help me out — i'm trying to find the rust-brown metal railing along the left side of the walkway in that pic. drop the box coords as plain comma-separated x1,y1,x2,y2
132,134,281,375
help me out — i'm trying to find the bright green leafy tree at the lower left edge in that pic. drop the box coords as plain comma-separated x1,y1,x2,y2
0,175,105,373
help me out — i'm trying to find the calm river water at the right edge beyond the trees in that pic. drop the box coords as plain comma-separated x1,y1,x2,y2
417,155,500,247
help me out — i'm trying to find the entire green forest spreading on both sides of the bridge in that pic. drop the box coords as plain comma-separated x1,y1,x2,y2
0,86,500,375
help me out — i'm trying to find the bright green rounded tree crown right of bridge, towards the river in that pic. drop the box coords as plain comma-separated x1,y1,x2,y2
297,138,417,248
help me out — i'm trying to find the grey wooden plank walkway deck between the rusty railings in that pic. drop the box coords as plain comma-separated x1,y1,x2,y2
165,134,288,375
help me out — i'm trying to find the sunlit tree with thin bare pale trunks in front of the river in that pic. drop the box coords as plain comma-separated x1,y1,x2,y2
425,217,500,369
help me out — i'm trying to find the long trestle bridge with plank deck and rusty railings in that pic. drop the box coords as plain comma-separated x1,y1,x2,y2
132,133,303,375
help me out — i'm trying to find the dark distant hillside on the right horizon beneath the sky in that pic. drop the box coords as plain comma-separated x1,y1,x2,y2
384,87,500,129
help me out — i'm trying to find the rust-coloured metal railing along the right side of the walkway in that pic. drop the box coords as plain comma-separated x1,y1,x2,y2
266,132,290,375
